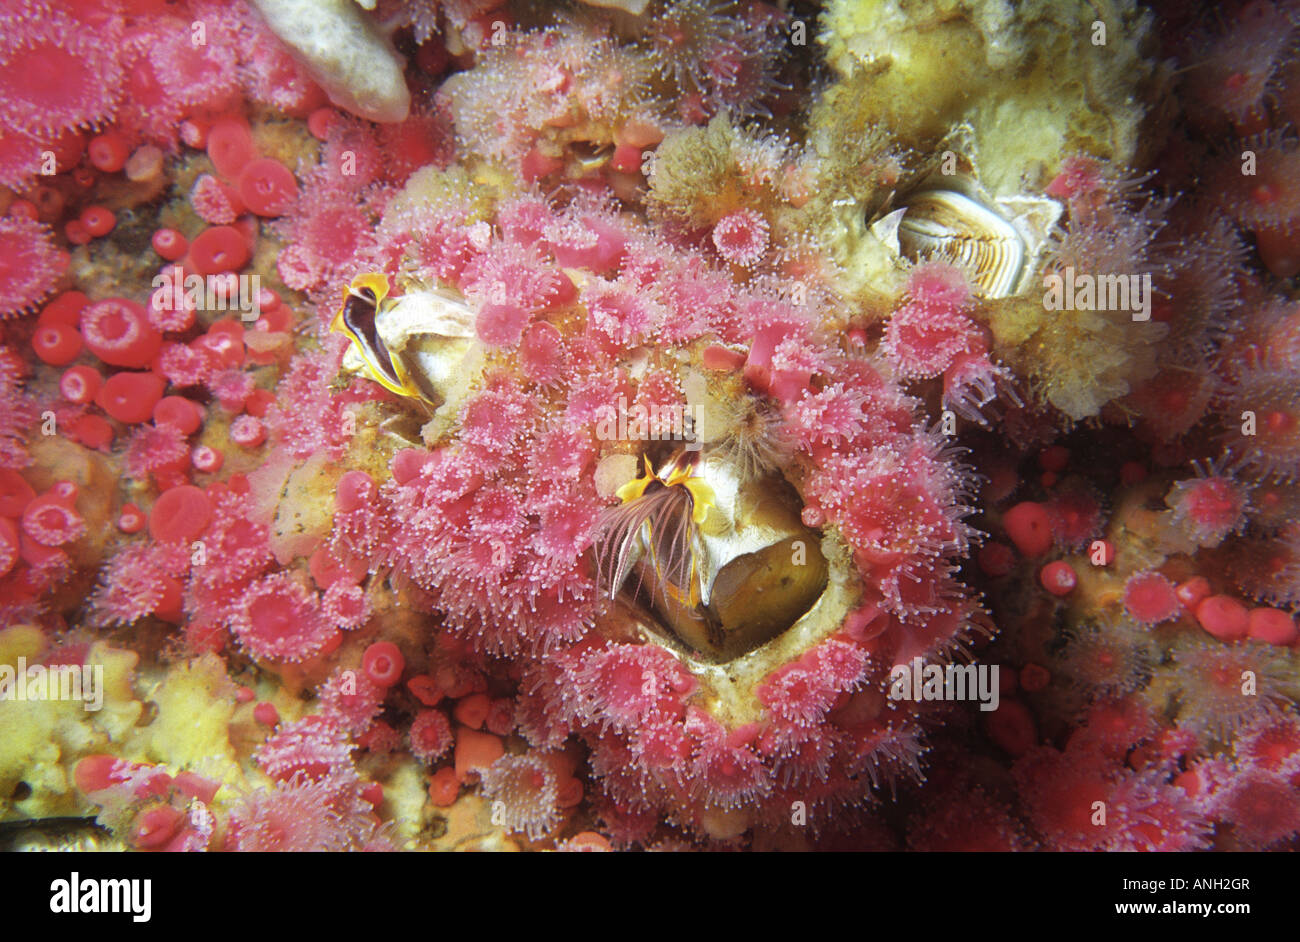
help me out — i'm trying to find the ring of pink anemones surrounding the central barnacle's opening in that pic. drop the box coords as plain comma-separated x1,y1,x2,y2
274,110,982,832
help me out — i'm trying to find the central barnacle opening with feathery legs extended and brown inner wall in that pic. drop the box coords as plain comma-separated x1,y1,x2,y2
597,448,829,663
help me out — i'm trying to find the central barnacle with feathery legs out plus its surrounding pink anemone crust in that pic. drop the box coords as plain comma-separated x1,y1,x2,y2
314,180,985,843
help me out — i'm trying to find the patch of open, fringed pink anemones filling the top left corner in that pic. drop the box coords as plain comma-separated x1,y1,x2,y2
0,0,324,323
